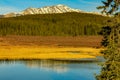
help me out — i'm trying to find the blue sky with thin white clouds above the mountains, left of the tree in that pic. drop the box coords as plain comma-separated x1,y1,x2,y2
0,0,101,14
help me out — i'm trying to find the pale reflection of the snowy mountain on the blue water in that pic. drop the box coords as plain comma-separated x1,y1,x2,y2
25,60,68,73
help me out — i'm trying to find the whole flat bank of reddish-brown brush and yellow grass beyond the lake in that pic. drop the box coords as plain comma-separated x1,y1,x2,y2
0,36,102,60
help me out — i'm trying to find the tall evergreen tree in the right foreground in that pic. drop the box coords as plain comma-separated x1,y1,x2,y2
96,0,120,80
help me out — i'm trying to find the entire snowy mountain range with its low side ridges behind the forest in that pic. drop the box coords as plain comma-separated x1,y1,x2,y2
1,4,102,17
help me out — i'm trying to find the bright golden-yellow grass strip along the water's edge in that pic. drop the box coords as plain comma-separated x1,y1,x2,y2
0,46,101,59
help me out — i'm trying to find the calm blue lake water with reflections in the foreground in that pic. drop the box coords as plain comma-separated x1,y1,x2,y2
0,60,100,80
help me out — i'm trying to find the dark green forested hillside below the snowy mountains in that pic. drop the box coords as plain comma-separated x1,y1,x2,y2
0,12,108,36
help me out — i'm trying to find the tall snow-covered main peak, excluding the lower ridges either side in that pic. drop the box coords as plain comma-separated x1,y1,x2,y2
20,4,81,15
